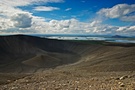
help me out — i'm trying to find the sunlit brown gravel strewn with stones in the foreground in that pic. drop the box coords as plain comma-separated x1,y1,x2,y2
0,69,135,90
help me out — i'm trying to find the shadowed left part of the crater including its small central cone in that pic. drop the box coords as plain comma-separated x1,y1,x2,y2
0,35,88,72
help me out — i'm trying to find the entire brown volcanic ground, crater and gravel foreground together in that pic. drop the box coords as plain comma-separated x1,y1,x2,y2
0,35,135,90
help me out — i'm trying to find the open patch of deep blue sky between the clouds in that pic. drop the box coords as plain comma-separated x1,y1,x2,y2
20,0,135,24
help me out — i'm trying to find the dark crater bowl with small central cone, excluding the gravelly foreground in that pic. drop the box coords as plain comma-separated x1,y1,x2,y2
0,35,135,72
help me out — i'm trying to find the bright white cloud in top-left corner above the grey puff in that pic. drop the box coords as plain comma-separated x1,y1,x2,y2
0,0,64,17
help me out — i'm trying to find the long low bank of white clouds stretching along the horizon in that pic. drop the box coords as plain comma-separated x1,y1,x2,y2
0,17,135,35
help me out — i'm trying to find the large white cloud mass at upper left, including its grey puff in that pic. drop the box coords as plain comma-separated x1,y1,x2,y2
0,0,63,33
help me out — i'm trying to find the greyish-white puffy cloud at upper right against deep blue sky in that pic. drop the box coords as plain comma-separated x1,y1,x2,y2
97,4,135,21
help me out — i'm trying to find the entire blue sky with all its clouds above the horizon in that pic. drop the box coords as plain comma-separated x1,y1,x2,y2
0,0,135,36
